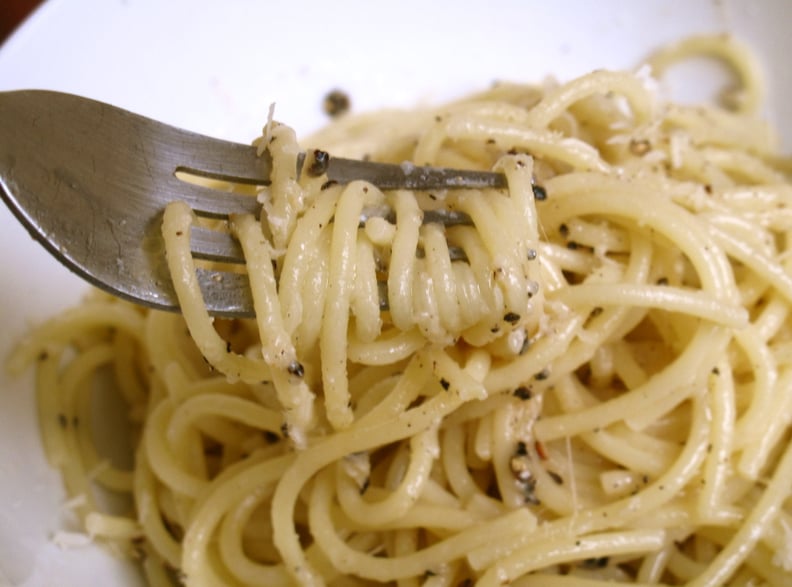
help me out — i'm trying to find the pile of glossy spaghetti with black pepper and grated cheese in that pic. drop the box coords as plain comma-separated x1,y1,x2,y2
11,37,792,587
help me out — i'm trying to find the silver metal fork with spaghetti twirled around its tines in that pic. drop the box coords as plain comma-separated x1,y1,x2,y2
0,90,506,317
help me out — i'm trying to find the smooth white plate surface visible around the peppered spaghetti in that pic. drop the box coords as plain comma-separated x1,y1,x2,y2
0,0,792,587
